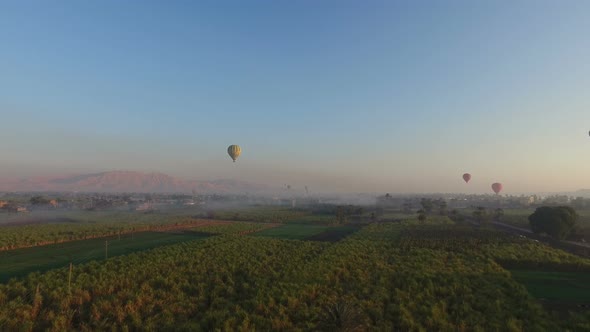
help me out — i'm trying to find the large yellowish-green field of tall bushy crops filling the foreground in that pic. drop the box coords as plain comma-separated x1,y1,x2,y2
0,218,590,331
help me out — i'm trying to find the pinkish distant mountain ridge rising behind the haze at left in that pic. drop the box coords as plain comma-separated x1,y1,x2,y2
0,171,269,193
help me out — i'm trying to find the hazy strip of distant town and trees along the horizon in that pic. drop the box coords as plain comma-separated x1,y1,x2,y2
0,192,590,213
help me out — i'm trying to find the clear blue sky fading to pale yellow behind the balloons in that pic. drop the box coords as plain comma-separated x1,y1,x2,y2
0,0,590,194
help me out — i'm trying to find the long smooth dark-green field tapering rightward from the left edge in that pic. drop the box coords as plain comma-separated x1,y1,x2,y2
0,231,208,282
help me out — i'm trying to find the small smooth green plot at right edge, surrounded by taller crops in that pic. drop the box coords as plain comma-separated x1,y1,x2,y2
510,270,590,304
